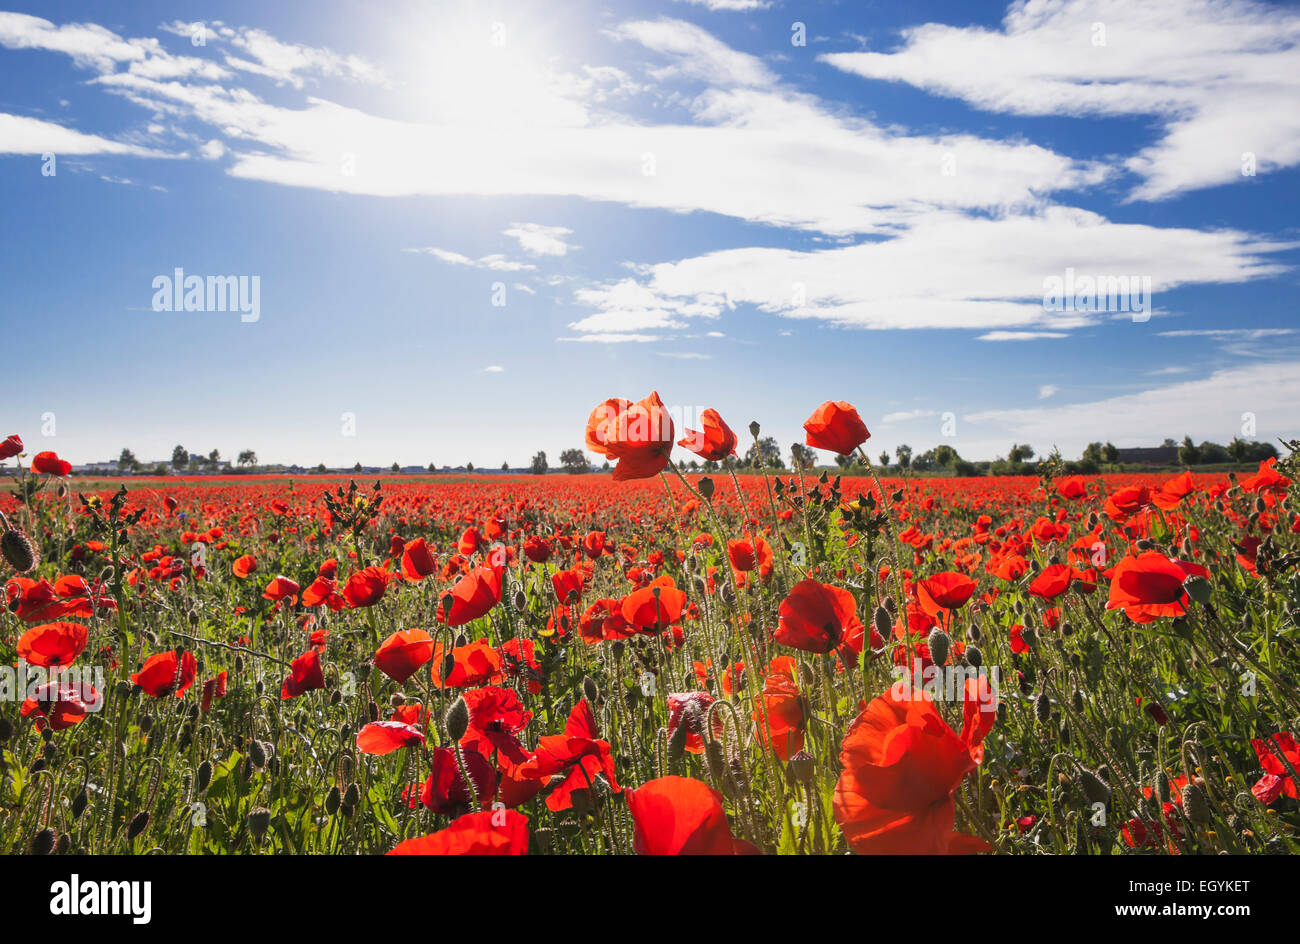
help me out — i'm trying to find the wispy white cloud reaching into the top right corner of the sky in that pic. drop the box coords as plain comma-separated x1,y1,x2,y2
820,0,1300,200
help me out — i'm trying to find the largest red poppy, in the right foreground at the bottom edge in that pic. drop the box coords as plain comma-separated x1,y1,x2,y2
833,680,997,854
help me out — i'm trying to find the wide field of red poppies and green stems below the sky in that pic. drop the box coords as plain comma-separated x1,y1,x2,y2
0,394,1300,856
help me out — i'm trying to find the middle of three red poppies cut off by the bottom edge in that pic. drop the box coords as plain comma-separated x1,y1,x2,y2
627,776,759,856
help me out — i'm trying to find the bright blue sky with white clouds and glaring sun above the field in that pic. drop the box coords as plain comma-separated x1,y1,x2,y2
0,0,1300,467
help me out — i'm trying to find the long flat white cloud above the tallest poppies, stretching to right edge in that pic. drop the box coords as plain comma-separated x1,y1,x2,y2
572,207,1290,341
